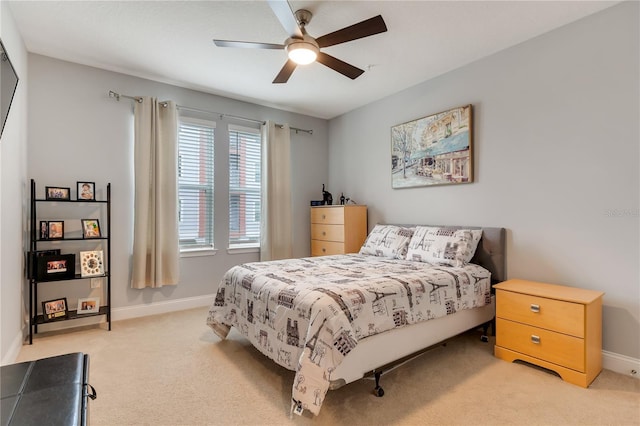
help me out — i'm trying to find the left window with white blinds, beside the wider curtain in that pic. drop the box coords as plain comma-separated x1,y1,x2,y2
178,117,215,250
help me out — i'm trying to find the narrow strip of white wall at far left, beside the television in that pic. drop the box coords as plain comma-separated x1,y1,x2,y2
0,2,28,364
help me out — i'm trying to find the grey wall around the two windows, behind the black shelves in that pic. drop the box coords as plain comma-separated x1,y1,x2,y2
23,54,328,321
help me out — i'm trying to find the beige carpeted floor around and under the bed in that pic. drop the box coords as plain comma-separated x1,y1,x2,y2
17,308,640,425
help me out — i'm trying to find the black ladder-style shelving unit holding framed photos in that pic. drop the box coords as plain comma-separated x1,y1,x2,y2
27,179,111,344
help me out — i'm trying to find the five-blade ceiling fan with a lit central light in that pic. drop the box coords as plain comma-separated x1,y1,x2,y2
213,0,387,83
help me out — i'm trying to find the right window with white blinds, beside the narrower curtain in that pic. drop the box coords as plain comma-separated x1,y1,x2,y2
229,126,262,248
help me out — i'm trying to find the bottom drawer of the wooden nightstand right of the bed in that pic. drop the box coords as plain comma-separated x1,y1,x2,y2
496,318,585,372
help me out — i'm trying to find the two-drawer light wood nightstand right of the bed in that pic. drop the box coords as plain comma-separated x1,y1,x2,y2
494,279,604,388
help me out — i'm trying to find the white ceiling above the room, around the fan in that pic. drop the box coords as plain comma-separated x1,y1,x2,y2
3,0,618,119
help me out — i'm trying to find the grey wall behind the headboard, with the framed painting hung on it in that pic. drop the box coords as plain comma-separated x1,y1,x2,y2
329,2,640,359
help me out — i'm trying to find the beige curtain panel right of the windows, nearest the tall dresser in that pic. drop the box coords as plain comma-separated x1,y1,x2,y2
260,121,293,261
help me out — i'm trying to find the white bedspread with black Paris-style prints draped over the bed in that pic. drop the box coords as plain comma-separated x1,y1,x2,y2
207,254,491,415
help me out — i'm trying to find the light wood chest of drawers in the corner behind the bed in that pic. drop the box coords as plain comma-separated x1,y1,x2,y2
311,204,367,256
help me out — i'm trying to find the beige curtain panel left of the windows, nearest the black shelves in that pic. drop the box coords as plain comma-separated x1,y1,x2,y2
131,97,179,288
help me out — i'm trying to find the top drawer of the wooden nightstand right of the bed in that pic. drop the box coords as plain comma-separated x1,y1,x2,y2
496,290,585,338
